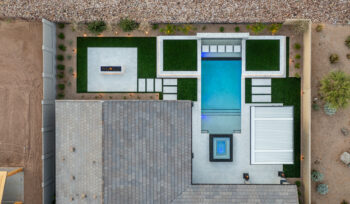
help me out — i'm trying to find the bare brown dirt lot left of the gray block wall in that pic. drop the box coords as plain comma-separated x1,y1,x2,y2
0,20,43,204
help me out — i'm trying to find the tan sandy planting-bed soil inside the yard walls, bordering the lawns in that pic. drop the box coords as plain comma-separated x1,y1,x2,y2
57,24,303,100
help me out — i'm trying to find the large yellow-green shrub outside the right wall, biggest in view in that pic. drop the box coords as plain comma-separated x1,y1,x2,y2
320,71,350,109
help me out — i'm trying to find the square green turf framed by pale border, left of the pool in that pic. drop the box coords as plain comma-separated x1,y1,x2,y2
163,40,197,71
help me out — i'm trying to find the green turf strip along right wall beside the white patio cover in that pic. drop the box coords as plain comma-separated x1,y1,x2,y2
271,78,301,178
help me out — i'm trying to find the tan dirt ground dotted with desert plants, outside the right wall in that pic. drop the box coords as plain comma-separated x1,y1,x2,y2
311,25,350,204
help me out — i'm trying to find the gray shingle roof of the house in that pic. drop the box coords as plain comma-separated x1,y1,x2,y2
56,101,298,203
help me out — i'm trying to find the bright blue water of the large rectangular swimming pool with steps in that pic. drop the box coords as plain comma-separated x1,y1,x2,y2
201,60,241,133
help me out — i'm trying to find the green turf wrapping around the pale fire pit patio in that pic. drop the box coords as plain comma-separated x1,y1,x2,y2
77,37,157,93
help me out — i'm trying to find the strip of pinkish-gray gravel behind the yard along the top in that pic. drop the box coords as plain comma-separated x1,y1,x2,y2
0,0,350,24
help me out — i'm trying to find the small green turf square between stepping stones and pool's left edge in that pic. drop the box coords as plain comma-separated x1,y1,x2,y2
177,78,197,101
